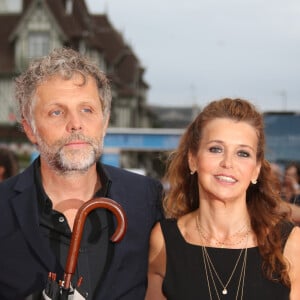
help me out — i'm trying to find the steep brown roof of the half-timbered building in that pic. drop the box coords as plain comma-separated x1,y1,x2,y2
0,0,148,96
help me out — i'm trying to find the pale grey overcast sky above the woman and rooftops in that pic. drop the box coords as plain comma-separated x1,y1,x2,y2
87,0,300,112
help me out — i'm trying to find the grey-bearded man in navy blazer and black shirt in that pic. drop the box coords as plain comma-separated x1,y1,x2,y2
0,48,161,300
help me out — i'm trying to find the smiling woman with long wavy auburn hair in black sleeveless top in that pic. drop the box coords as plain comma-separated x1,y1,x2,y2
146,99,300,300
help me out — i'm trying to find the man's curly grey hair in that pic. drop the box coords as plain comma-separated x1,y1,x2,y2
15,48,112,126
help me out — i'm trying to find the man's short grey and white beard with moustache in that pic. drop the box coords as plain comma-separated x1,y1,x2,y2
36,133,103,174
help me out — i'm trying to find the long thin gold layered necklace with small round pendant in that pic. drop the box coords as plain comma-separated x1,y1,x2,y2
196,216,250,300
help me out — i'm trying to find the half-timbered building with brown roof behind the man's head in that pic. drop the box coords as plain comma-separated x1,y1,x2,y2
0,0,150,128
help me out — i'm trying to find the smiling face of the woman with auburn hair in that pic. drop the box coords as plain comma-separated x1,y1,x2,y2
189,118,260,202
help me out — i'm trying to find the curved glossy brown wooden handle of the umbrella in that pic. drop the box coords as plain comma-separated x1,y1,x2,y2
62,197,127,289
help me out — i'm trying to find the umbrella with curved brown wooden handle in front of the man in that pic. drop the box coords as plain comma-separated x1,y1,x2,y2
43,197,127,300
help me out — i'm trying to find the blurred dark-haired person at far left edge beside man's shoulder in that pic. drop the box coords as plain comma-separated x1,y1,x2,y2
0,147,19,182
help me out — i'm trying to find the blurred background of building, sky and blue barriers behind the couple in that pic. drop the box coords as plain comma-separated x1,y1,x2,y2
0,0,300,178
